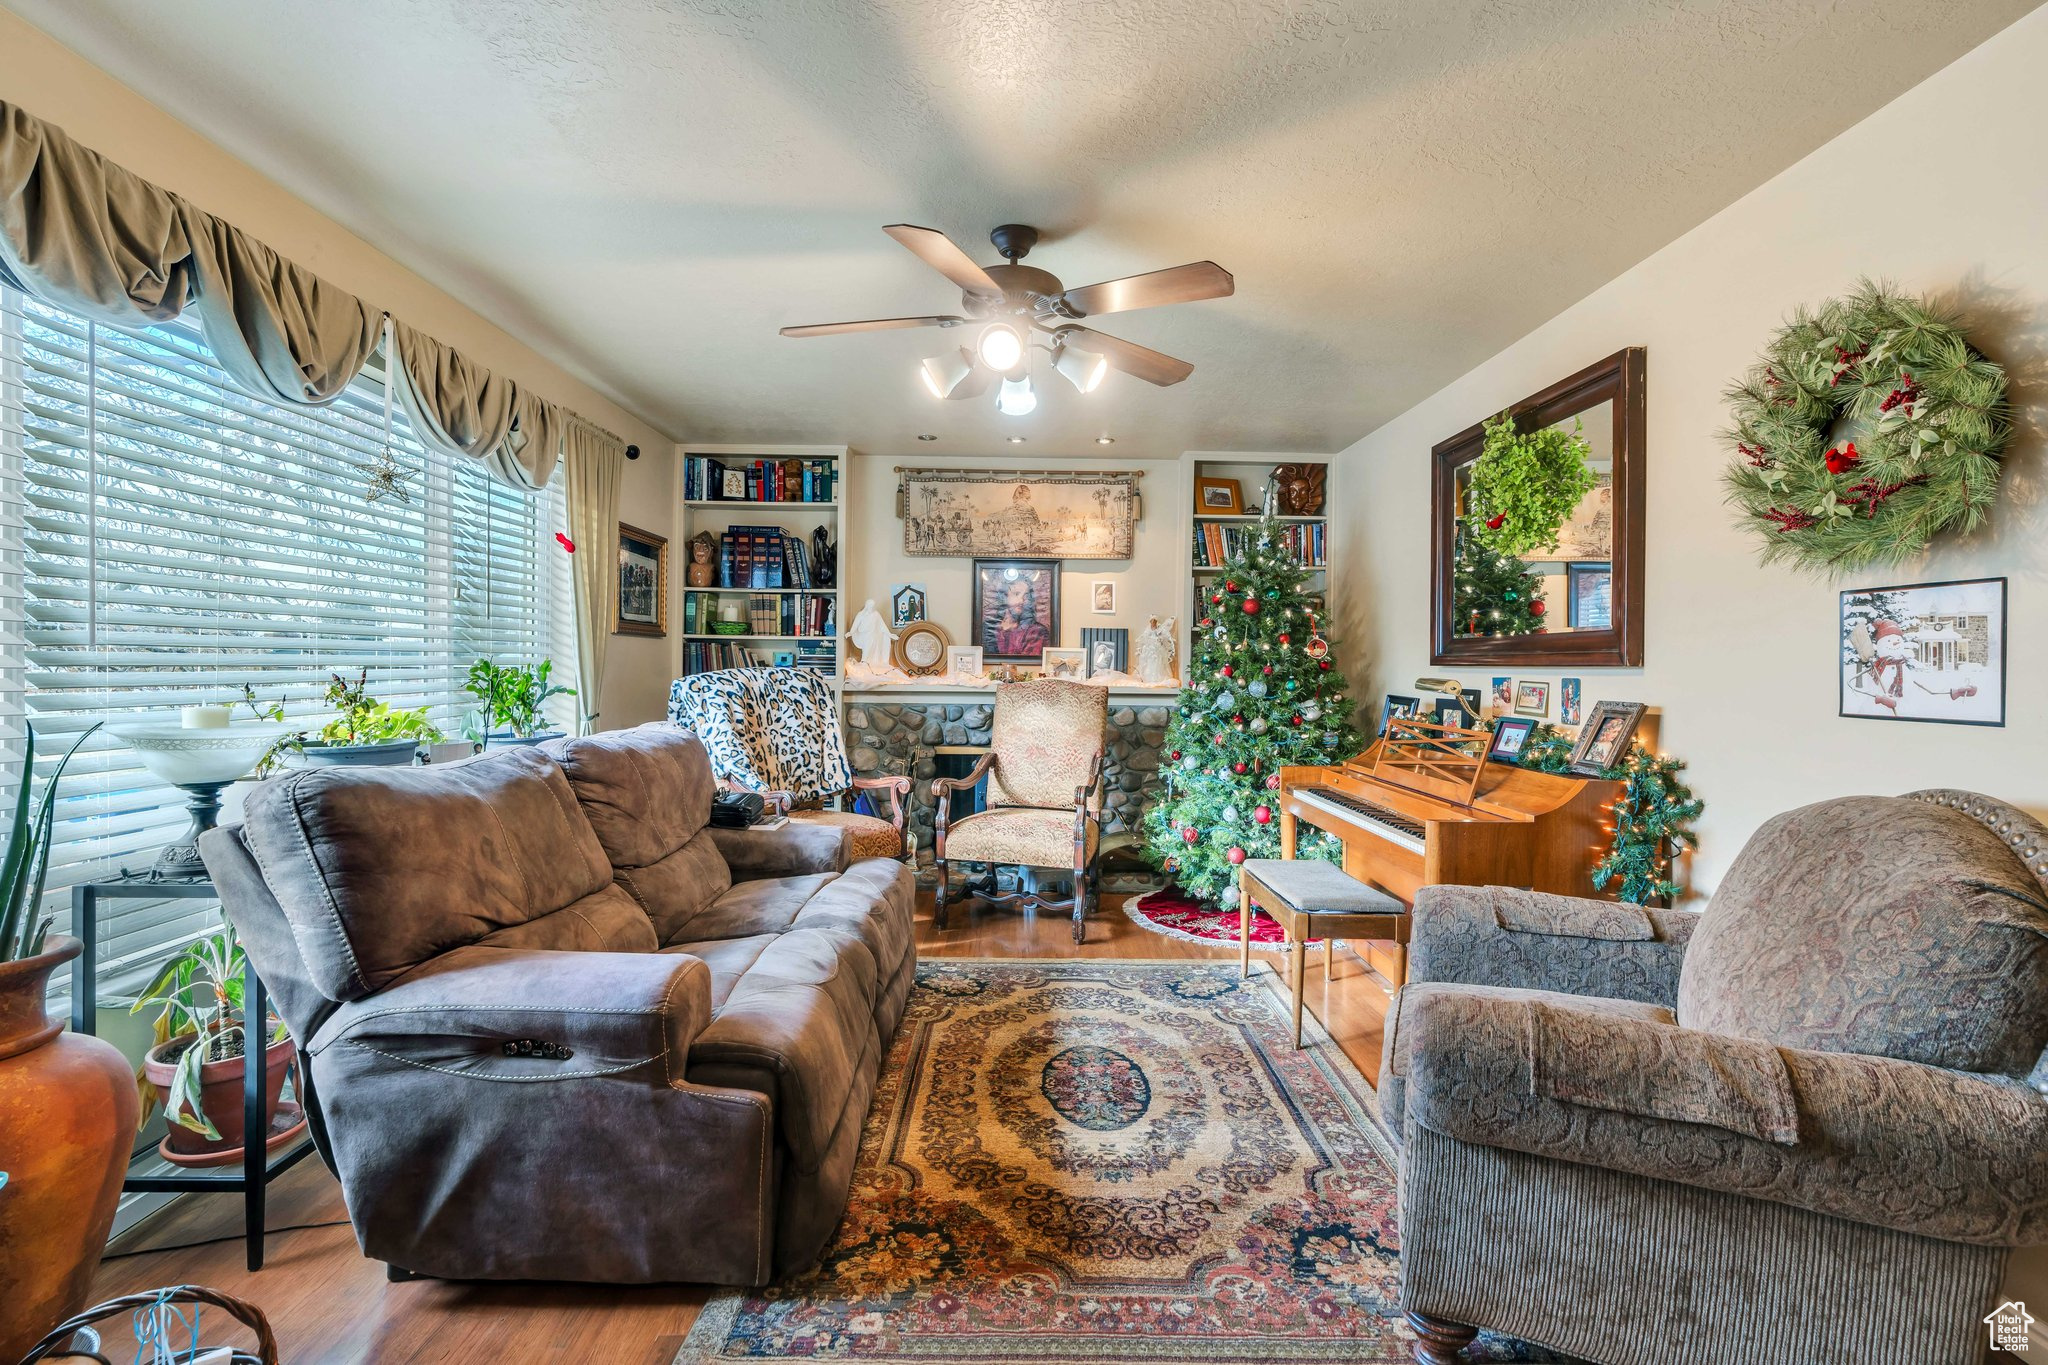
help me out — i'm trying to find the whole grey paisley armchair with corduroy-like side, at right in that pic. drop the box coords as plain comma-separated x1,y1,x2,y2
1380,792,2048,1365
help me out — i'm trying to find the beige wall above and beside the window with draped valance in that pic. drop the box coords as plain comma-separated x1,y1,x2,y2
0,10,680,726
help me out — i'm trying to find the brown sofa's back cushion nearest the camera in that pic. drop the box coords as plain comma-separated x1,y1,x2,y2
242,749,630,1001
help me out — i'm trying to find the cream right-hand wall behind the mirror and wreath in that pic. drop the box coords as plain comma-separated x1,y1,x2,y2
1333,10,2048,1347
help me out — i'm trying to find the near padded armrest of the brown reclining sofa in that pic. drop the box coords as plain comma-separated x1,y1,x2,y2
307,945,711,1085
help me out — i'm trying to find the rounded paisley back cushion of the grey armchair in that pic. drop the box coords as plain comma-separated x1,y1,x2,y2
1677,794,2048,1076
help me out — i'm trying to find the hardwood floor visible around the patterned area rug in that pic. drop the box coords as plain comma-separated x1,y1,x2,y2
94,892,1386,1365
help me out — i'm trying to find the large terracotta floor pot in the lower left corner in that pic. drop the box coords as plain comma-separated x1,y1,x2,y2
0,937,141,1361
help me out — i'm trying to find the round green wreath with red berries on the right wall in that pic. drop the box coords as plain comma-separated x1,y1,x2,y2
1720,280,2011,569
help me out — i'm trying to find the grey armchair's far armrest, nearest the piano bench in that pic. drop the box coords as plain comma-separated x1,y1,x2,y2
1409,886,1700,1009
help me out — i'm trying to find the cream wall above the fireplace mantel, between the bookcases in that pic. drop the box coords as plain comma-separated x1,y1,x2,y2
842,454,1188,649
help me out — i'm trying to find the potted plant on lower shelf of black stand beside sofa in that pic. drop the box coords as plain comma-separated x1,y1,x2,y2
133,919,305,1166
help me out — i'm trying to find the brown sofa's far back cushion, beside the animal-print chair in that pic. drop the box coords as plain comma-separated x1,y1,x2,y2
543,722,733,941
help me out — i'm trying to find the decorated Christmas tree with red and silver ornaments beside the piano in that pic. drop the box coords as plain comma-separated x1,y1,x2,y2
1145,520,1356,905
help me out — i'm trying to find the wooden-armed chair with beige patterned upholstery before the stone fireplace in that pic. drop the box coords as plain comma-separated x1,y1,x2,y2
932,679,1110,943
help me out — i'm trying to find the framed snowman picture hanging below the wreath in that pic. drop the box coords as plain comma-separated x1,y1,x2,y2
1839,579,2005,724
